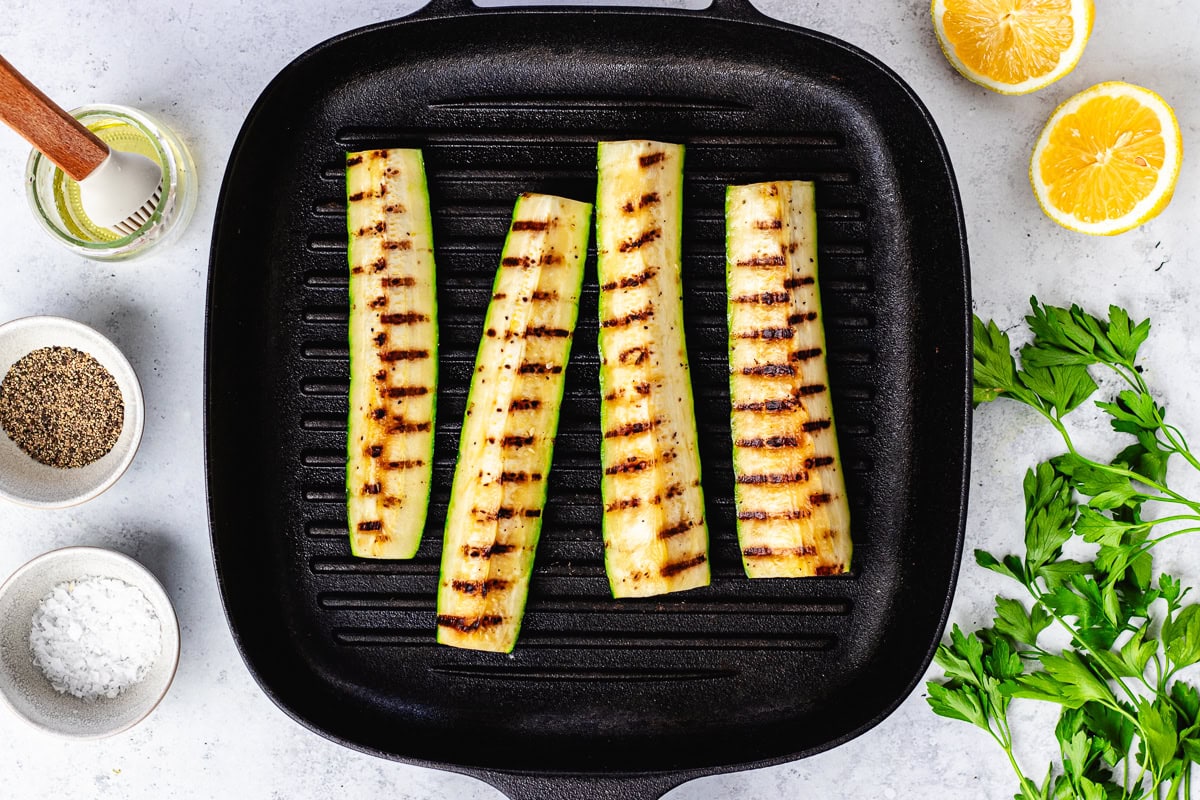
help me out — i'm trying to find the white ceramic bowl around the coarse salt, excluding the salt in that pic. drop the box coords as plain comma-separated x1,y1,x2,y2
0,547,179,739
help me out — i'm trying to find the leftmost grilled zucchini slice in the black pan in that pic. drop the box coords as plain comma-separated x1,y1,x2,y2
346,150,438,559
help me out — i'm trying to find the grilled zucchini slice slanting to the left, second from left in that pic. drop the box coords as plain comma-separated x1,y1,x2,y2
437,194,592,652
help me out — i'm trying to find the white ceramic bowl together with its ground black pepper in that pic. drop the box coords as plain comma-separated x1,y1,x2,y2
0,317,144,509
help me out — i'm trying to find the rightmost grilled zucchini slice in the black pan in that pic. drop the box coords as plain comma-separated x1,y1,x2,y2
725,181,851,578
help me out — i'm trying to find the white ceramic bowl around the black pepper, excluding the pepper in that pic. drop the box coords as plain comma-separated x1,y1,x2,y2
0,317,145,509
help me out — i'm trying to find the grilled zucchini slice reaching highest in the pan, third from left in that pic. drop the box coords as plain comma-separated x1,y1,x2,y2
596,142,709,597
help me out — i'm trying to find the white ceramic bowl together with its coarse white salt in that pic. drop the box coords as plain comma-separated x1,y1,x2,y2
0,547,179,739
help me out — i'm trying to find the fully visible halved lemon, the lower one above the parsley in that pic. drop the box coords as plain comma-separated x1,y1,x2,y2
1030,80,1183,235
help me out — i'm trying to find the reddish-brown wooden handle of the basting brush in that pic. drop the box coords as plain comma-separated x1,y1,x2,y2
0,55,108,181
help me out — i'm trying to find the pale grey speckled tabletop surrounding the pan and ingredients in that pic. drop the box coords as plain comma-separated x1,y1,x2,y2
0,0,1200,800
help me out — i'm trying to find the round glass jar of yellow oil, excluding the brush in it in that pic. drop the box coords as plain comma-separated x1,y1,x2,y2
25,104,197,261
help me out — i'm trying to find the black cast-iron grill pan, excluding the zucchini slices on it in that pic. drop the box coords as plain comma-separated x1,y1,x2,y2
205,0,971,798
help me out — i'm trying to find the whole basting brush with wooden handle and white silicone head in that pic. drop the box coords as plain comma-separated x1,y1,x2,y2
0,56,162,236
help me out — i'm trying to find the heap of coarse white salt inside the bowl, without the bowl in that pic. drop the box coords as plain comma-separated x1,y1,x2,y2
29,576,162,700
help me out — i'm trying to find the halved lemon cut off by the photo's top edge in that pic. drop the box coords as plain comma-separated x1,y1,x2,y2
934,0,1096,95
